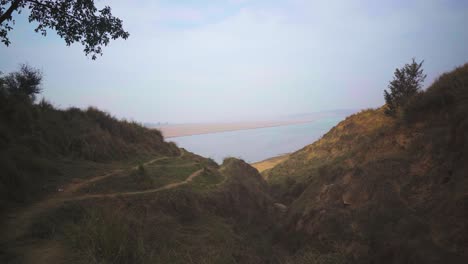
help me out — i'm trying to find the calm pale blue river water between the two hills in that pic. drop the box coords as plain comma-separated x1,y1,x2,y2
168,116,344,164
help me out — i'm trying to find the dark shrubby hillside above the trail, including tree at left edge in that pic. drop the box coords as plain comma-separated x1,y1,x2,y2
0,66,179,211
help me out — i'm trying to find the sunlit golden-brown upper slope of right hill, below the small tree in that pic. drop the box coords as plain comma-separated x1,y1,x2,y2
264,108,395,204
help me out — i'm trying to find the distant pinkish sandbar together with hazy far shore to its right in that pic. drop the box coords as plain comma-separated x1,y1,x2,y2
145,109,358,138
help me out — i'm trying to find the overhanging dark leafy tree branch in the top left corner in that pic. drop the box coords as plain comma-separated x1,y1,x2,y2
0,0,129,60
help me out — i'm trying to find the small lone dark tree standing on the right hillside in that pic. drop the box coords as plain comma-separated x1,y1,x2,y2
384,58,427,116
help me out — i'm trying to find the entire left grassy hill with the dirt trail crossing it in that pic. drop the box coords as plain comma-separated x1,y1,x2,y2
0,92,288,263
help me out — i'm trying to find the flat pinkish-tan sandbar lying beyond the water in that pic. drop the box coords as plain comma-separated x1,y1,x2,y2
153,118,319,138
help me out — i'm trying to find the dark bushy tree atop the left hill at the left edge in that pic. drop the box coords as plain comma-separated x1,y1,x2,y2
0,64,42,103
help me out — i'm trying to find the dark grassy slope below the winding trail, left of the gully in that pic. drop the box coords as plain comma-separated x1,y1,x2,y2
0,153,282,263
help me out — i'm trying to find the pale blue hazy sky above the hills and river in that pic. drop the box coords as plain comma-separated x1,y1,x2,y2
0,0,468,123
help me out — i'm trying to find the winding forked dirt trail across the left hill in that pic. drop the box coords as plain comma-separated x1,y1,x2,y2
0,153,204,248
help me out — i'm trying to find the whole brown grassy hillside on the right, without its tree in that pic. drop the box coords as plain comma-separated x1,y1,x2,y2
264,64,468,263
